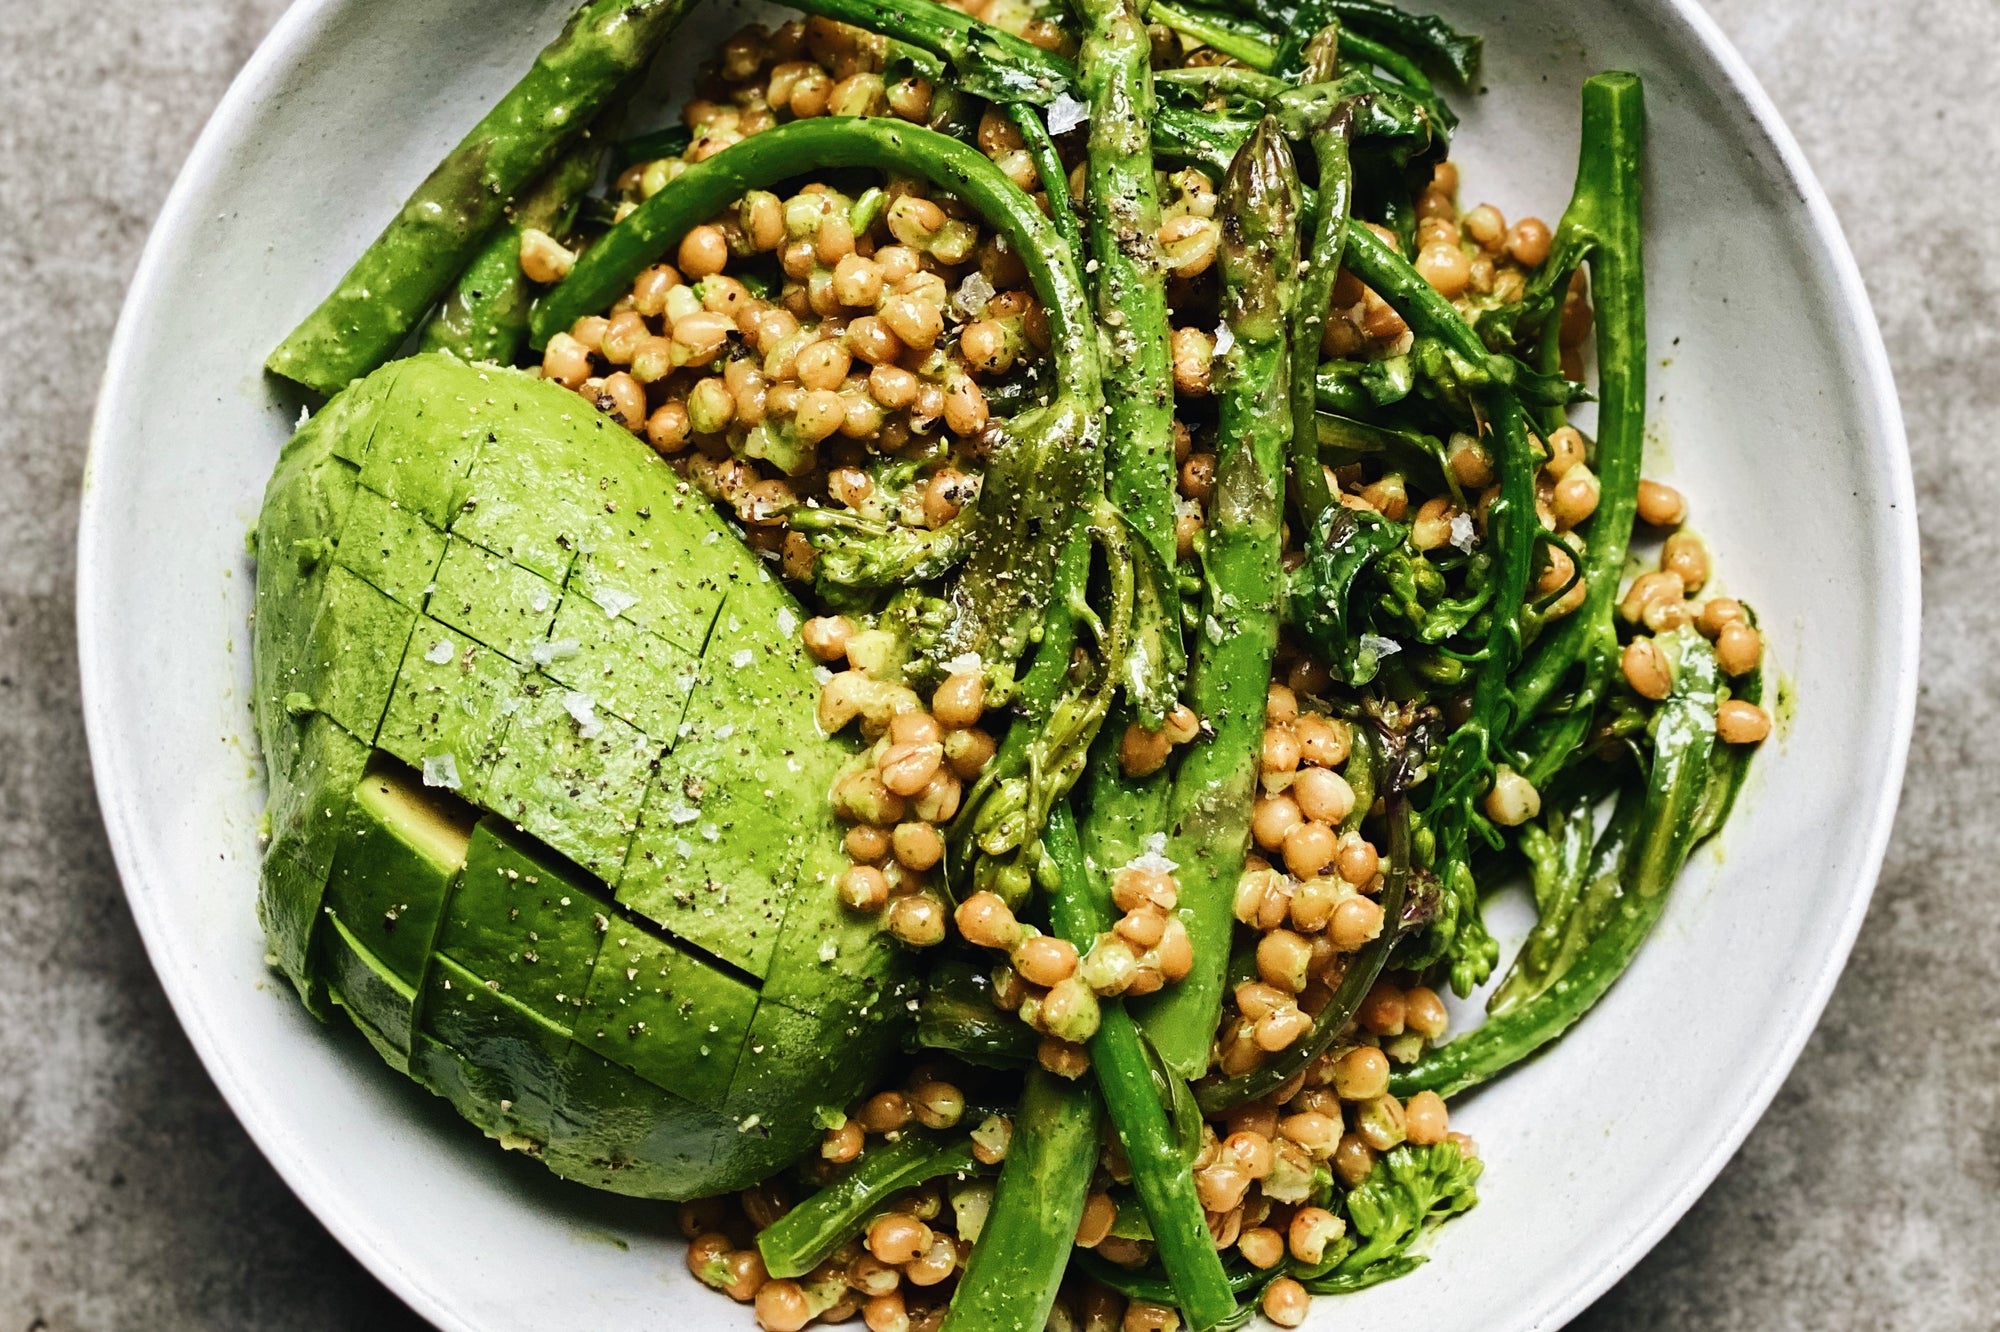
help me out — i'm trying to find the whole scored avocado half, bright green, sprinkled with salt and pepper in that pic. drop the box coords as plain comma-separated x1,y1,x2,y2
254,354,908,1198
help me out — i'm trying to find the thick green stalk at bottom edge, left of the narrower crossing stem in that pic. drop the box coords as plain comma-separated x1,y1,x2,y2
944,1068,1100,1332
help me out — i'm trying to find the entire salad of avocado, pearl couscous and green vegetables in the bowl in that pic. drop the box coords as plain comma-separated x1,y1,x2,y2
254,0,1770,1332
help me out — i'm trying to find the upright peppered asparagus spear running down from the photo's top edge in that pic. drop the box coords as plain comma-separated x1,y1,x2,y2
1078,0,1184,726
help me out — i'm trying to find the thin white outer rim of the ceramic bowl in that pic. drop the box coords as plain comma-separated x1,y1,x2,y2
76,0,1922,1332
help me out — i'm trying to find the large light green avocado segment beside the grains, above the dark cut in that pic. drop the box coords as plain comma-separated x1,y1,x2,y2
618,592,844,978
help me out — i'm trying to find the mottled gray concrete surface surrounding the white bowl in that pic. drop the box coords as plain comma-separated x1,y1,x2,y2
0,0,2000,1332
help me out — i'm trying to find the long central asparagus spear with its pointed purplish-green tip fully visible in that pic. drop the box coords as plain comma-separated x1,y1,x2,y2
1144,118,1316,1078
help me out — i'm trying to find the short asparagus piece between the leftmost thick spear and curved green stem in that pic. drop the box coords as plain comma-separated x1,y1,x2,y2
420,138,604,366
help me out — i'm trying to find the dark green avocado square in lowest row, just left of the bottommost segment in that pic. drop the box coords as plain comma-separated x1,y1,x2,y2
410,956,572,1150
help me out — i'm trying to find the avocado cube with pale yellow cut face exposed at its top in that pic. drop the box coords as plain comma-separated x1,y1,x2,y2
326,762,478,986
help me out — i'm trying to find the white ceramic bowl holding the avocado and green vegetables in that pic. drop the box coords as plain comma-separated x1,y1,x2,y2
78,0,1918,1332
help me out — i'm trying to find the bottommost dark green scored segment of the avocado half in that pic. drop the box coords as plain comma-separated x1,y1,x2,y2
546,1046,748,1198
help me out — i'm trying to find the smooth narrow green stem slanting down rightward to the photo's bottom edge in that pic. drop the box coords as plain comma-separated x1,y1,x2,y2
1028,804,1236,1332
